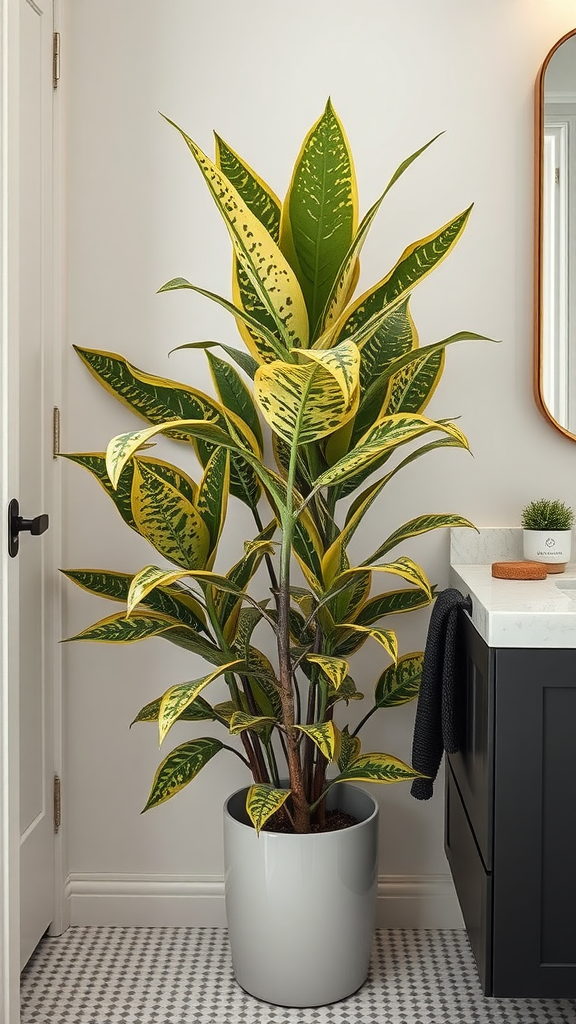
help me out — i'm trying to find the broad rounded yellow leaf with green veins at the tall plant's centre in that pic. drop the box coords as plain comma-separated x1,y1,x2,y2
254,344,360,445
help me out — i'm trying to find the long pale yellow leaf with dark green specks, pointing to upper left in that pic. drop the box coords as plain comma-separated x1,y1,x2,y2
161,118,308,348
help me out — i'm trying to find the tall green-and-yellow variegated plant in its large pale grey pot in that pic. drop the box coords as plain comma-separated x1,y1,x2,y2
61,102,481,1006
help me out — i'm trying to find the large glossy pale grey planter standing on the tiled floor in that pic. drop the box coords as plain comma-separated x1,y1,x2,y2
224,782,378,1007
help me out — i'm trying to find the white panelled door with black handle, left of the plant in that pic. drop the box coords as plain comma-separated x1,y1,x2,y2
15,0,54,967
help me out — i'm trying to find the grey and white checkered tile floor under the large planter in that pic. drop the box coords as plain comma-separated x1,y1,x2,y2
22,928,576,1024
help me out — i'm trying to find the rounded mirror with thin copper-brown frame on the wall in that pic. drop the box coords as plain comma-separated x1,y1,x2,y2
535,30,576,440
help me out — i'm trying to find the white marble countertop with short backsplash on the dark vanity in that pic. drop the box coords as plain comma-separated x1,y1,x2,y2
450,527,576,648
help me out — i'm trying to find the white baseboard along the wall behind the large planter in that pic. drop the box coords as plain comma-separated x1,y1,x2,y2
65,873,463,928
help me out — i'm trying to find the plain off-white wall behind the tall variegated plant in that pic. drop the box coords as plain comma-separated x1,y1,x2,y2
61,0,576,925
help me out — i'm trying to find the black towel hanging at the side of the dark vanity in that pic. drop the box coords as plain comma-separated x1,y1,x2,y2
410,588,471,800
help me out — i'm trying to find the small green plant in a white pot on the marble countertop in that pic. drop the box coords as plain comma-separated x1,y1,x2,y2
521,498,574,572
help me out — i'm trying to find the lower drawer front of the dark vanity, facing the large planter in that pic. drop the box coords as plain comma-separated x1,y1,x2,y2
445,765,492,995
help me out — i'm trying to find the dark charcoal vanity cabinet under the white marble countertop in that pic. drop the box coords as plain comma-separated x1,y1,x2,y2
446,614,576,998
